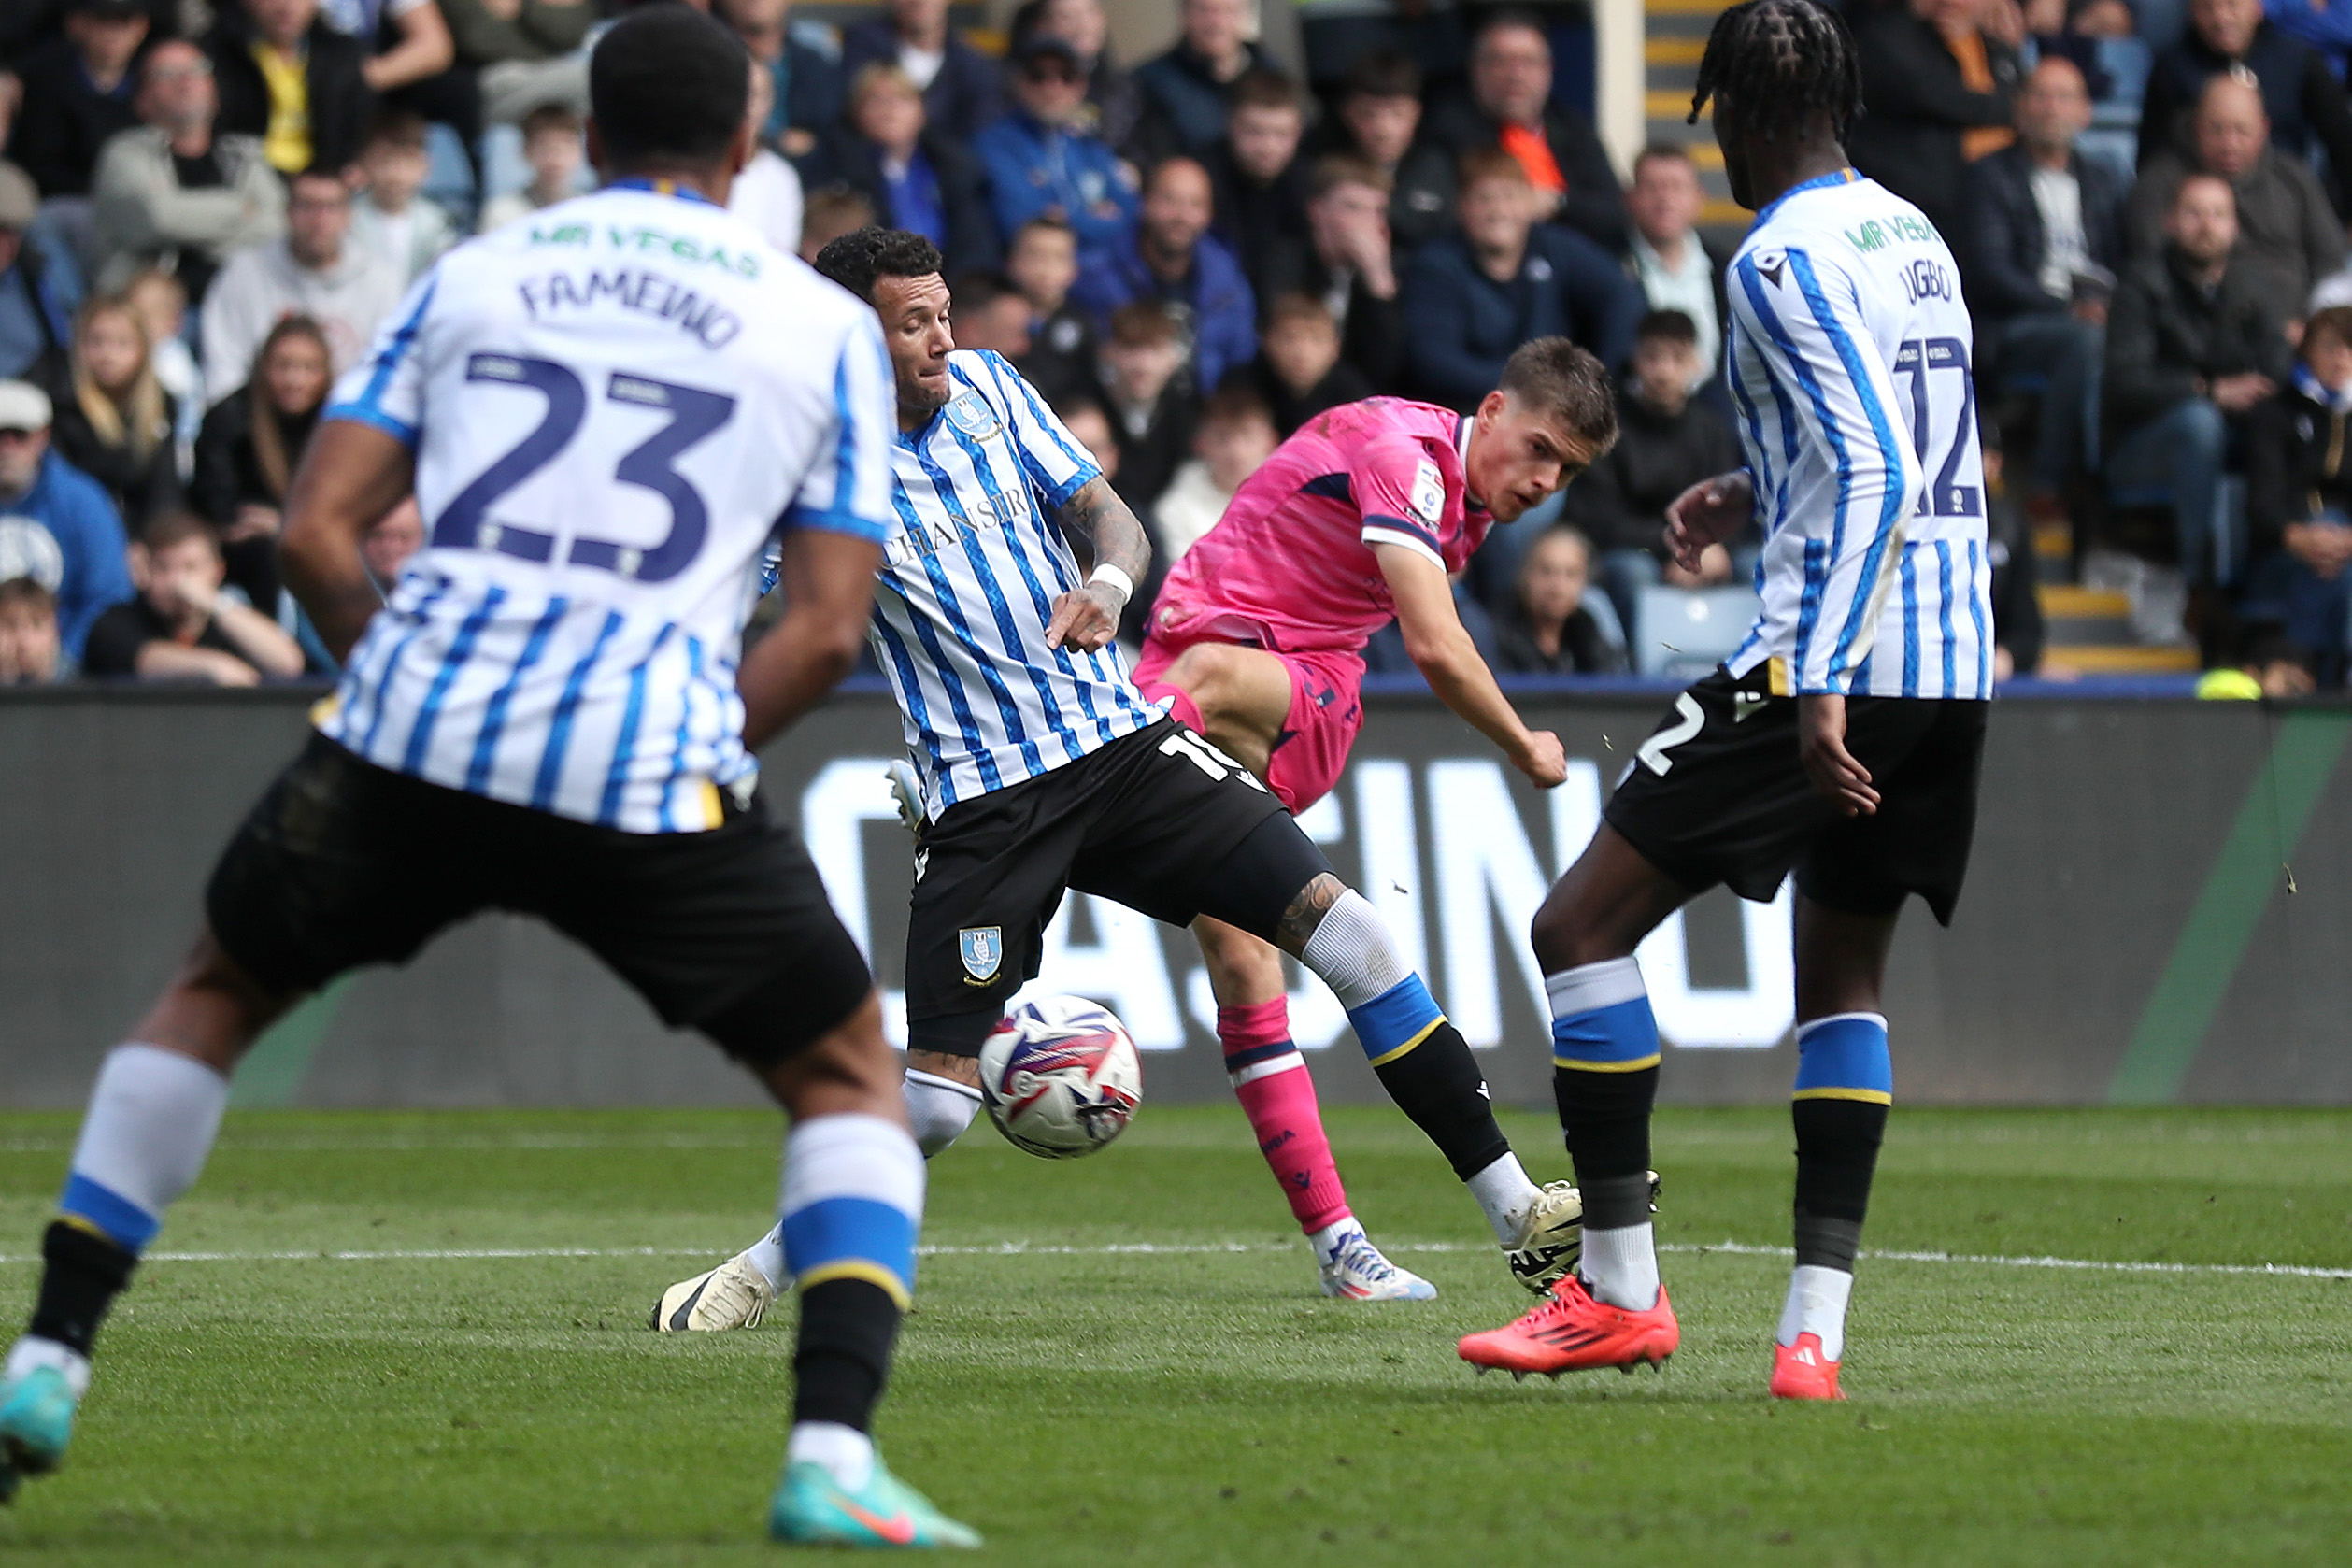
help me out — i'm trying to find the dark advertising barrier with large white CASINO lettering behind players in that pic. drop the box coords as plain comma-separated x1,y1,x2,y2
0,689,2352,1107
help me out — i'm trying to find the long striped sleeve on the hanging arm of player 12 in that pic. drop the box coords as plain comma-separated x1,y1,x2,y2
1732,249,1921,693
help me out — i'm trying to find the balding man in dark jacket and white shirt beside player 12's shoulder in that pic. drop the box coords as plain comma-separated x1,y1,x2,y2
1960,59,2124,496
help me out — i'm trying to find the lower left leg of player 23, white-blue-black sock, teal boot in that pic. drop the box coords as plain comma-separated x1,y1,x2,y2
0,931,292,1503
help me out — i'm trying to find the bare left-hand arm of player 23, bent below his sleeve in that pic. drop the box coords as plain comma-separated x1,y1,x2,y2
278,419,417,661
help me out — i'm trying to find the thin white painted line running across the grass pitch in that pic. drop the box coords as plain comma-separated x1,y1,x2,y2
0,1241,2352,1279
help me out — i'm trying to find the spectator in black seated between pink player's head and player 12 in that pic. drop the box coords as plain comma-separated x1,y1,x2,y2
1566,310,1743,625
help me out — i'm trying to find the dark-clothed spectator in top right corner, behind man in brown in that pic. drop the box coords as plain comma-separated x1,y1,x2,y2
2140,0,2352,207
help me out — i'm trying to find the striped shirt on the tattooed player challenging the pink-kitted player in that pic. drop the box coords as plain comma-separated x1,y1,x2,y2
873,350,1164,818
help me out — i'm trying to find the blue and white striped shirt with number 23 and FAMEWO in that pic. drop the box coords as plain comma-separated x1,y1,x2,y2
318,183,896,833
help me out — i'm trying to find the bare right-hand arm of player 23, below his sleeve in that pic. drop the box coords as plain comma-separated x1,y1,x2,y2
736,529,882,750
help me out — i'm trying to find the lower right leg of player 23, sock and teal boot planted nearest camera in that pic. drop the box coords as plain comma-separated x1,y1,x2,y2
767,992,981,1547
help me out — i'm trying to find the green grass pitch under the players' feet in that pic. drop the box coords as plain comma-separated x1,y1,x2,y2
0,1105,2352,1568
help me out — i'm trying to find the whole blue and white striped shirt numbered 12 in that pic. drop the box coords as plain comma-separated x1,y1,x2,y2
1726,169,1992,698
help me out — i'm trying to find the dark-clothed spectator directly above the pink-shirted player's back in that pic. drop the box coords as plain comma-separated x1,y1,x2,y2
1259,155,1404,388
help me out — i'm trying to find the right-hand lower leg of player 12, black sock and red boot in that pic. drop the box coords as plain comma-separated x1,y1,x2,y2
1771,898,1896,1399
